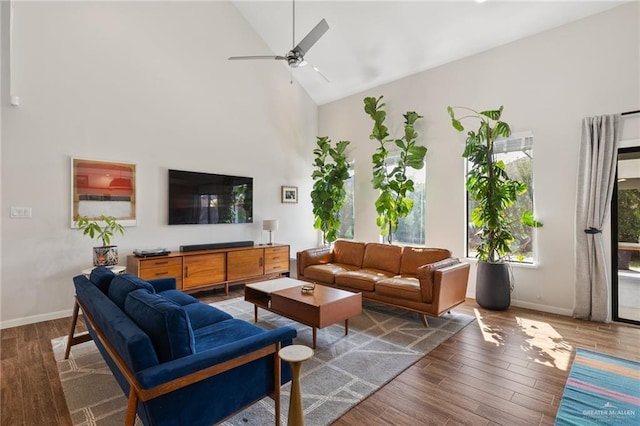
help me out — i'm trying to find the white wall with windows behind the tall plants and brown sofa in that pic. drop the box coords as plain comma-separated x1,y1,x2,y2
319,2,640,315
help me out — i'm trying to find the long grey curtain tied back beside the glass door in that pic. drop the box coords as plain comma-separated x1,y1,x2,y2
573,114,620,322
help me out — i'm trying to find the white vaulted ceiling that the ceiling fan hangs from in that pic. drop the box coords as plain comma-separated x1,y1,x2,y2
233,0,625,105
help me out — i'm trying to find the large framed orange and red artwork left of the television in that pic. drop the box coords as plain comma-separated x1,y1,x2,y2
71,157,136,228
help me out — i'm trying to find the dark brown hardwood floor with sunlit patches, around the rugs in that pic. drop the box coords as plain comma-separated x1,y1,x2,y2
0,286,640,426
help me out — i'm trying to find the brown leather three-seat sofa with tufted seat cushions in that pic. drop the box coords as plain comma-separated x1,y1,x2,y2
296,240,469,325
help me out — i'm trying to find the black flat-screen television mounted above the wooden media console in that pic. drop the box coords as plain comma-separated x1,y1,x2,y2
169,170,253,225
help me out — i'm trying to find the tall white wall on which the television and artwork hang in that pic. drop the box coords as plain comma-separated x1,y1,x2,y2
0,2,317,328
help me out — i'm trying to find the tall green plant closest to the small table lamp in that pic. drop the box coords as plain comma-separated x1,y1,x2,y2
311,136,350,244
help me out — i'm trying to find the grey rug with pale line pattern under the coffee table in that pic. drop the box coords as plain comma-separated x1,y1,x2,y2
52,297,474,426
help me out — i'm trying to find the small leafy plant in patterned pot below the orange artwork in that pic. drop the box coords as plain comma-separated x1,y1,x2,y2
75,215,124,266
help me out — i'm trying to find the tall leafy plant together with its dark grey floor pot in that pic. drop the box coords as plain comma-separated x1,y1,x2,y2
447,106,542,310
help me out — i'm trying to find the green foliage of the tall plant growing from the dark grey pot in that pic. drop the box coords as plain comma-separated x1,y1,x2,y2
447,106,542,263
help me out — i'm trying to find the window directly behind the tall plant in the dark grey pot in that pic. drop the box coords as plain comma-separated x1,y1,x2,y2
467,133,535,263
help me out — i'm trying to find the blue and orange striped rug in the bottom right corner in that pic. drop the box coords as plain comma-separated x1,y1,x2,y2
556,348,640,426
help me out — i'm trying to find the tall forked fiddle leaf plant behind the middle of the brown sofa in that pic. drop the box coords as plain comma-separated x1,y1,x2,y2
364,96,427,244
